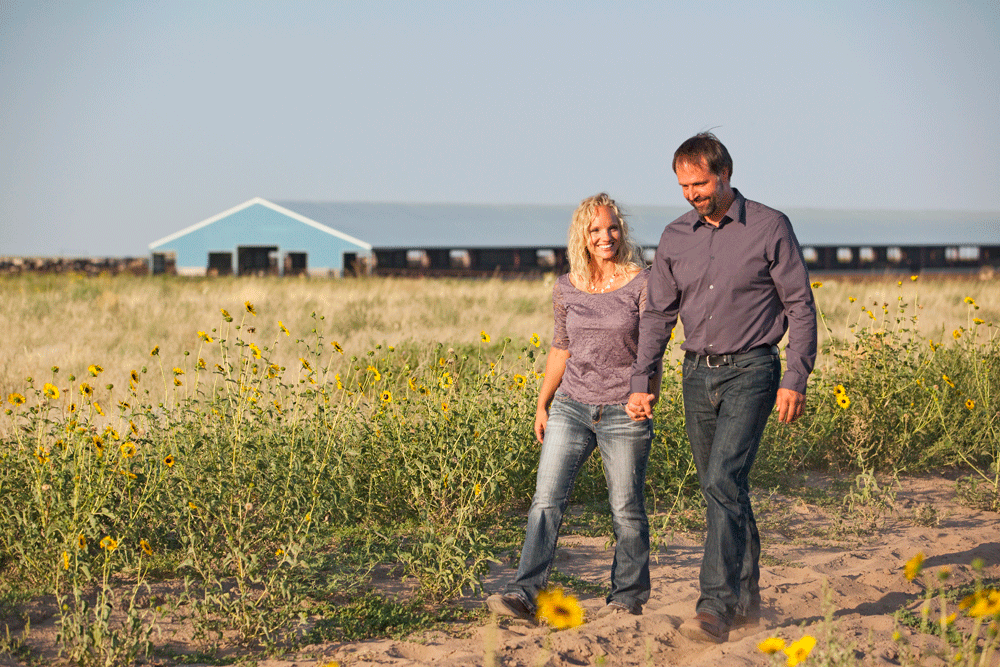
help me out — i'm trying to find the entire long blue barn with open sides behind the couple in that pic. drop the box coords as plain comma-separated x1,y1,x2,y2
149,197,1000,276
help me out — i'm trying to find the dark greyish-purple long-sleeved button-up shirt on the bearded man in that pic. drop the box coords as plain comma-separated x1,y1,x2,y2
630,188,816,394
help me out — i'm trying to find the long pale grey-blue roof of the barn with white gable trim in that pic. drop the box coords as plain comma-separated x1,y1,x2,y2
149,197,1000,250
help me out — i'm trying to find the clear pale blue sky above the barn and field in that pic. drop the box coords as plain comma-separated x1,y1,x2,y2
0,0,1000,255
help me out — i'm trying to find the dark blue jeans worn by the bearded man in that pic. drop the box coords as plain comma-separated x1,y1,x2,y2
683,354,781,622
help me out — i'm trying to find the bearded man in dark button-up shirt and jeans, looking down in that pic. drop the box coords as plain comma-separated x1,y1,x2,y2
626,133,816,643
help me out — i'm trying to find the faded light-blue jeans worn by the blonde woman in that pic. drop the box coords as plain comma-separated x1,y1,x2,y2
507,394,653,613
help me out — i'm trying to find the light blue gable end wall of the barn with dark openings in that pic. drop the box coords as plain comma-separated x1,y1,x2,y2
149,197,372,276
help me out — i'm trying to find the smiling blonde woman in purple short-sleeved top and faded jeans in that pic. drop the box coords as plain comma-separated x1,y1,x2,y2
486,193,659,619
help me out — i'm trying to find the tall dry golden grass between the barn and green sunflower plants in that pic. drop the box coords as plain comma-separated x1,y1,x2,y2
0,275,1000,396
